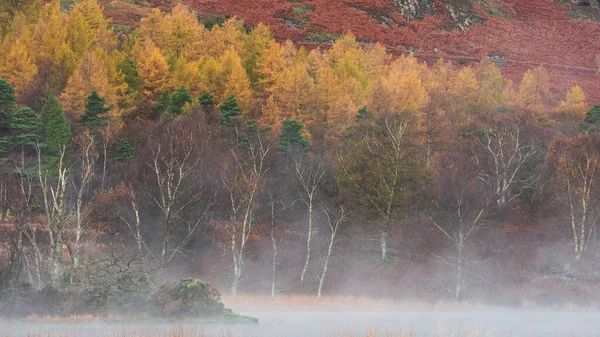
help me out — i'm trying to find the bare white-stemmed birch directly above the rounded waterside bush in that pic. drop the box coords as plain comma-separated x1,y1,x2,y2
149,119,214,267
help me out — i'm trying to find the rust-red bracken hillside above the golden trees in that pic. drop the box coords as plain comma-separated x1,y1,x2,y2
106,0,600,104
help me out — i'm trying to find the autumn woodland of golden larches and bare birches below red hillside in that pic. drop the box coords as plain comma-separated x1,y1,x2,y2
0,0,600,310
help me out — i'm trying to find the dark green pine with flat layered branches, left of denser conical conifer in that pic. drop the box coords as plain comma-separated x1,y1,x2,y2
10,107,39,167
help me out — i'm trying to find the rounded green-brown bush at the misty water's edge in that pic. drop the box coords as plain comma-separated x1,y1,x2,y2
152,278,224,318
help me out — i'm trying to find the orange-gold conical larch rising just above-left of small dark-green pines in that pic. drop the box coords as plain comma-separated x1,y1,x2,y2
138,44,169,98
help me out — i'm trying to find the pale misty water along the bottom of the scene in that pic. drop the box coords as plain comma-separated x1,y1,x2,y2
0,308,600,337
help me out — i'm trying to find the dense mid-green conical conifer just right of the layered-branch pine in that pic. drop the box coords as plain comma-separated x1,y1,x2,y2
39,96,71,156
